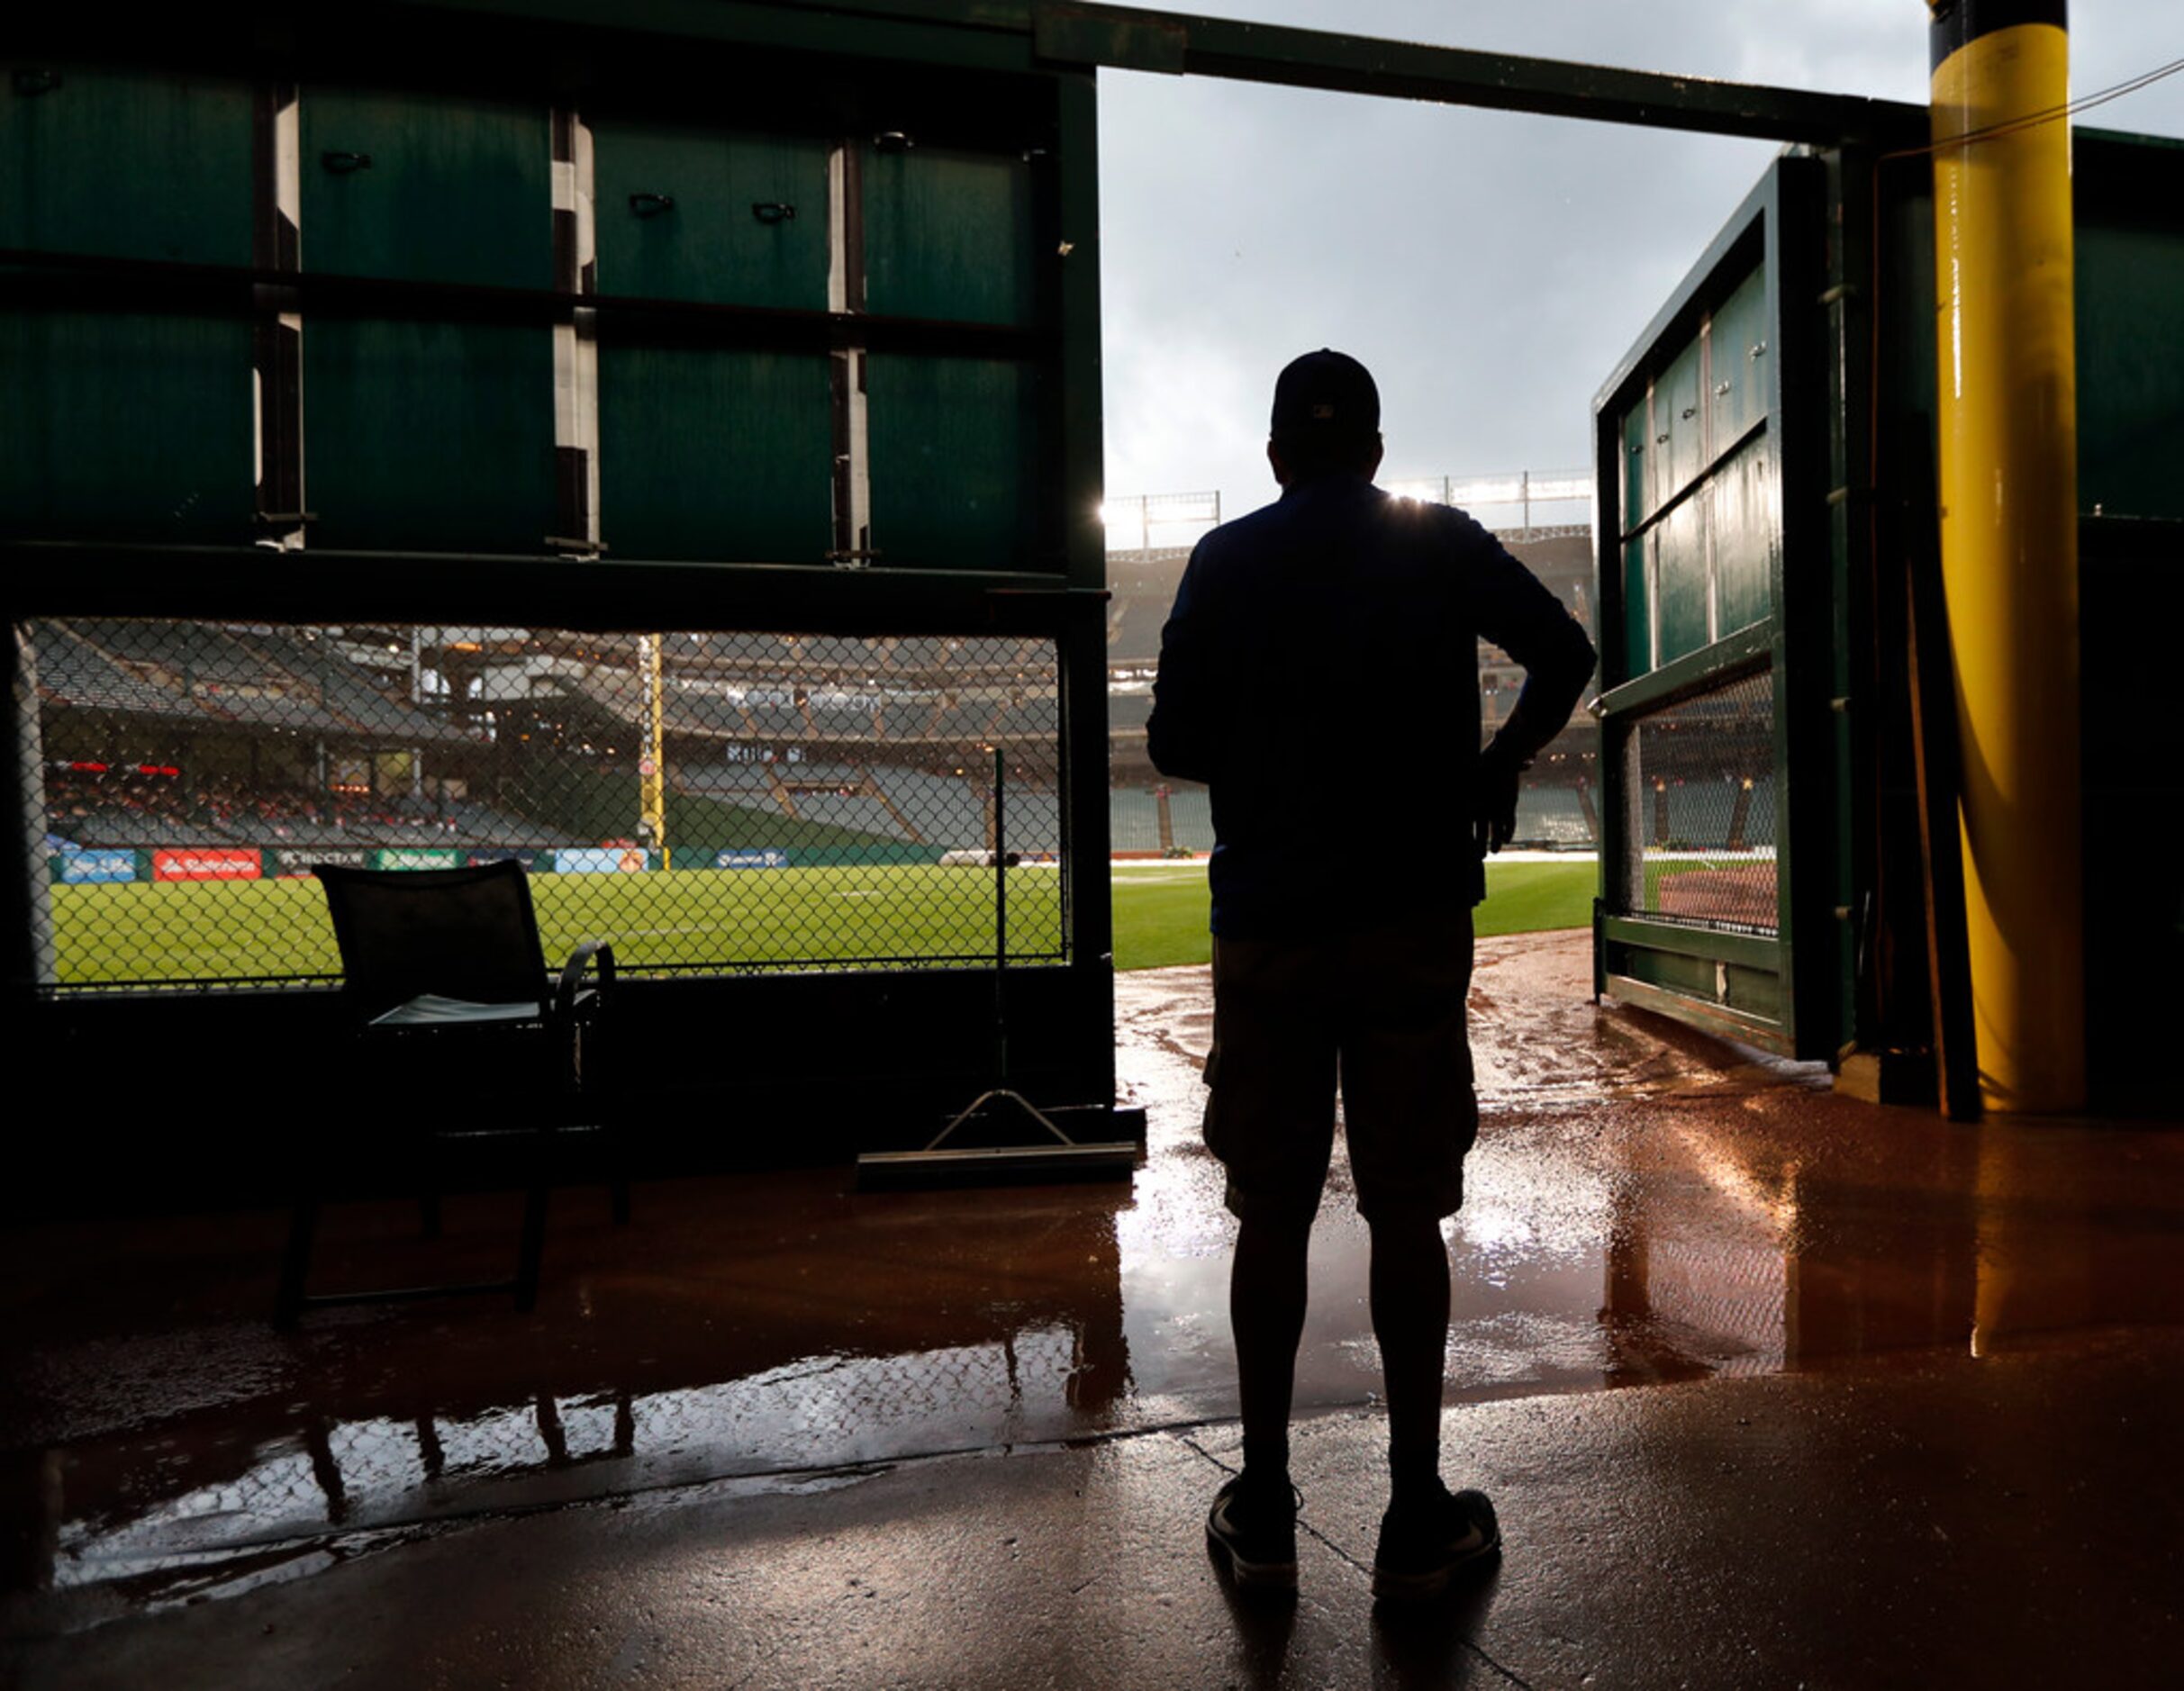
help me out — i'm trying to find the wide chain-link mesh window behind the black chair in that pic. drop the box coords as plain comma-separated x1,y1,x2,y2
15,619,1065,990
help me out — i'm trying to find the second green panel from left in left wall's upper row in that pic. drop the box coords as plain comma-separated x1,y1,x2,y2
302,87,553,288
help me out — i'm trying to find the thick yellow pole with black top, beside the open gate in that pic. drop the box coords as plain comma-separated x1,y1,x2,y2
1928,0,2086,1112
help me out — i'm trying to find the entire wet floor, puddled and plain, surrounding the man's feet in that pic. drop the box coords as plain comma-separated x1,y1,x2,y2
0,935,2184,1685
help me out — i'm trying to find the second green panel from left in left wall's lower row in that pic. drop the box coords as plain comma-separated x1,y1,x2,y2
304,319,555,553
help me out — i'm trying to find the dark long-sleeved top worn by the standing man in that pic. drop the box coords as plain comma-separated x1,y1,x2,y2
1146,476,1594,939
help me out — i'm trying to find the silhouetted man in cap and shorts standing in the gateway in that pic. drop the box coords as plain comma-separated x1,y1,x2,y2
1149,352,1594,1597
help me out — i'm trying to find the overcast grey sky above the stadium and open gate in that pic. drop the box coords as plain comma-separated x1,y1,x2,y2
1099,0,2184,524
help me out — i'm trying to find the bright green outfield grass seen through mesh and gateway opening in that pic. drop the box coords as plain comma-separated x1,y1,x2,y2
50,859,1597,985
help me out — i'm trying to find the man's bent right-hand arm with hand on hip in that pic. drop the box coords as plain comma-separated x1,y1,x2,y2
1474,524,1599,856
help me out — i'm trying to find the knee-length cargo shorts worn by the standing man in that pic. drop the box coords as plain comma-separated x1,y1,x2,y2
1206,909,1479,1221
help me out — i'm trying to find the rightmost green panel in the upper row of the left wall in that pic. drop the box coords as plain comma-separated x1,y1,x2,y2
865,147,1038,323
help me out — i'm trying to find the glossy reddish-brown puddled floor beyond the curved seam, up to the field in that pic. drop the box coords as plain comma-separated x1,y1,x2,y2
0,935,2184,1604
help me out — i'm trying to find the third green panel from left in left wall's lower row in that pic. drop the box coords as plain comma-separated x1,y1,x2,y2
598,345,834,564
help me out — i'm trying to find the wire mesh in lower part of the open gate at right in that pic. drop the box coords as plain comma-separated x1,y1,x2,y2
1629,668,1780,933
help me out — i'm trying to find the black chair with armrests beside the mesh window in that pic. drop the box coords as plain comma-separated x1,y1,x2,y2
276,861,629,1326
